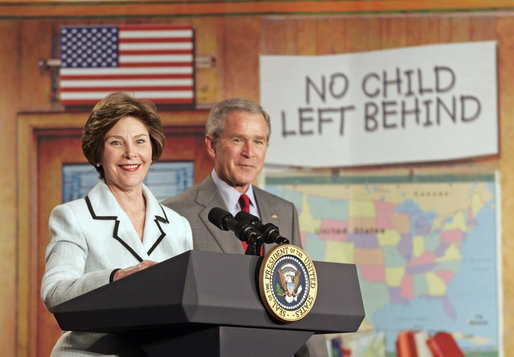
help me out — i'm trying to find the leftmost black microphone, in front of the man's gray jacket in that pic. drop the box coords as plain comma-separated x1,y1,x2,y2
208,207,264,245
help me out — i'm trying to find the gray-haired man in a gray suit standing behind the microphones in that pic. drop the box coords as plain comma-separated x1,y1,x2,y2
163,98,328,356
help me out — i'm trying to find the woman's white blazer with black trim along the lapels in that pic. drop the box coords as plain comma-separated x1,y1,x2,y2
41,181,193,311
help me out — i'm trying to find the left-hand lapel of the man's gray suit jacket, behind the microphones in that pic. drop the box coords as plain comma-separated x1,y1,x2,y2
196,175,244,254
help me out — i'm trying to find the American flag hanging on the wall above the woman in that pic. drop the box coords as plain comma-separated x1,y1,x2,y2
59,25,195,106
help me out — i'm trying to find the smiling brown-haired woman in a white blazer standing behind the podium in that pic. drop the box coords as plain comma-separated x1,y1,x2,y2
41,93,193,356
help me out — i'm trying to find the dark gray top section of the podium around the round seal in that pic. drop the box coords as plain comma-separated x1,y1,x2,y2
53,250,364,333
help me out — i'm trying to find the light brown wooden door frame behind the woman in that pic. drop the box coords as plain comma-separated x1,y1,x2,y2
15,108,208,357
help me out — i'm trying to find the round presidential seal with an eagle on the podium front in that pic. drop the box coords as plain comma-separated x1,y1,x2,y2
259,244,318,322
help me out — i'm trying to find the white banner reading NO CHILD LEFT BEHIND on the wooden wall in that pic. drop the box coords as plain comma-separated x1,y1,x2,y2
260,41,498,167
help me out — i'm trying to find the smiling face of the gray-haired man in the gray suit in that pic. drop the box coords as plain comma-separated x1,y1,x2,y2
205,111,268,193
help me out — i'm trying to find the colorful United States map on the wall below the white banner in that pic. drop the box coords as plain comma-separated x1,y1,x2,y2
265,173,502,356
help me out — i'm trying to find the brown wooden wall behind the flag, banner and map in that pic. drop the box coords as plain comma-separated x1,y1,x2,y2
0,1,514,356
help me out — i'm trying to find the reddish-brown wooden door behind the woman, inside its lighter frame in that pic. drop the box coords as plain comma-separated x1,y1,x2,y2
32,127,212,356
